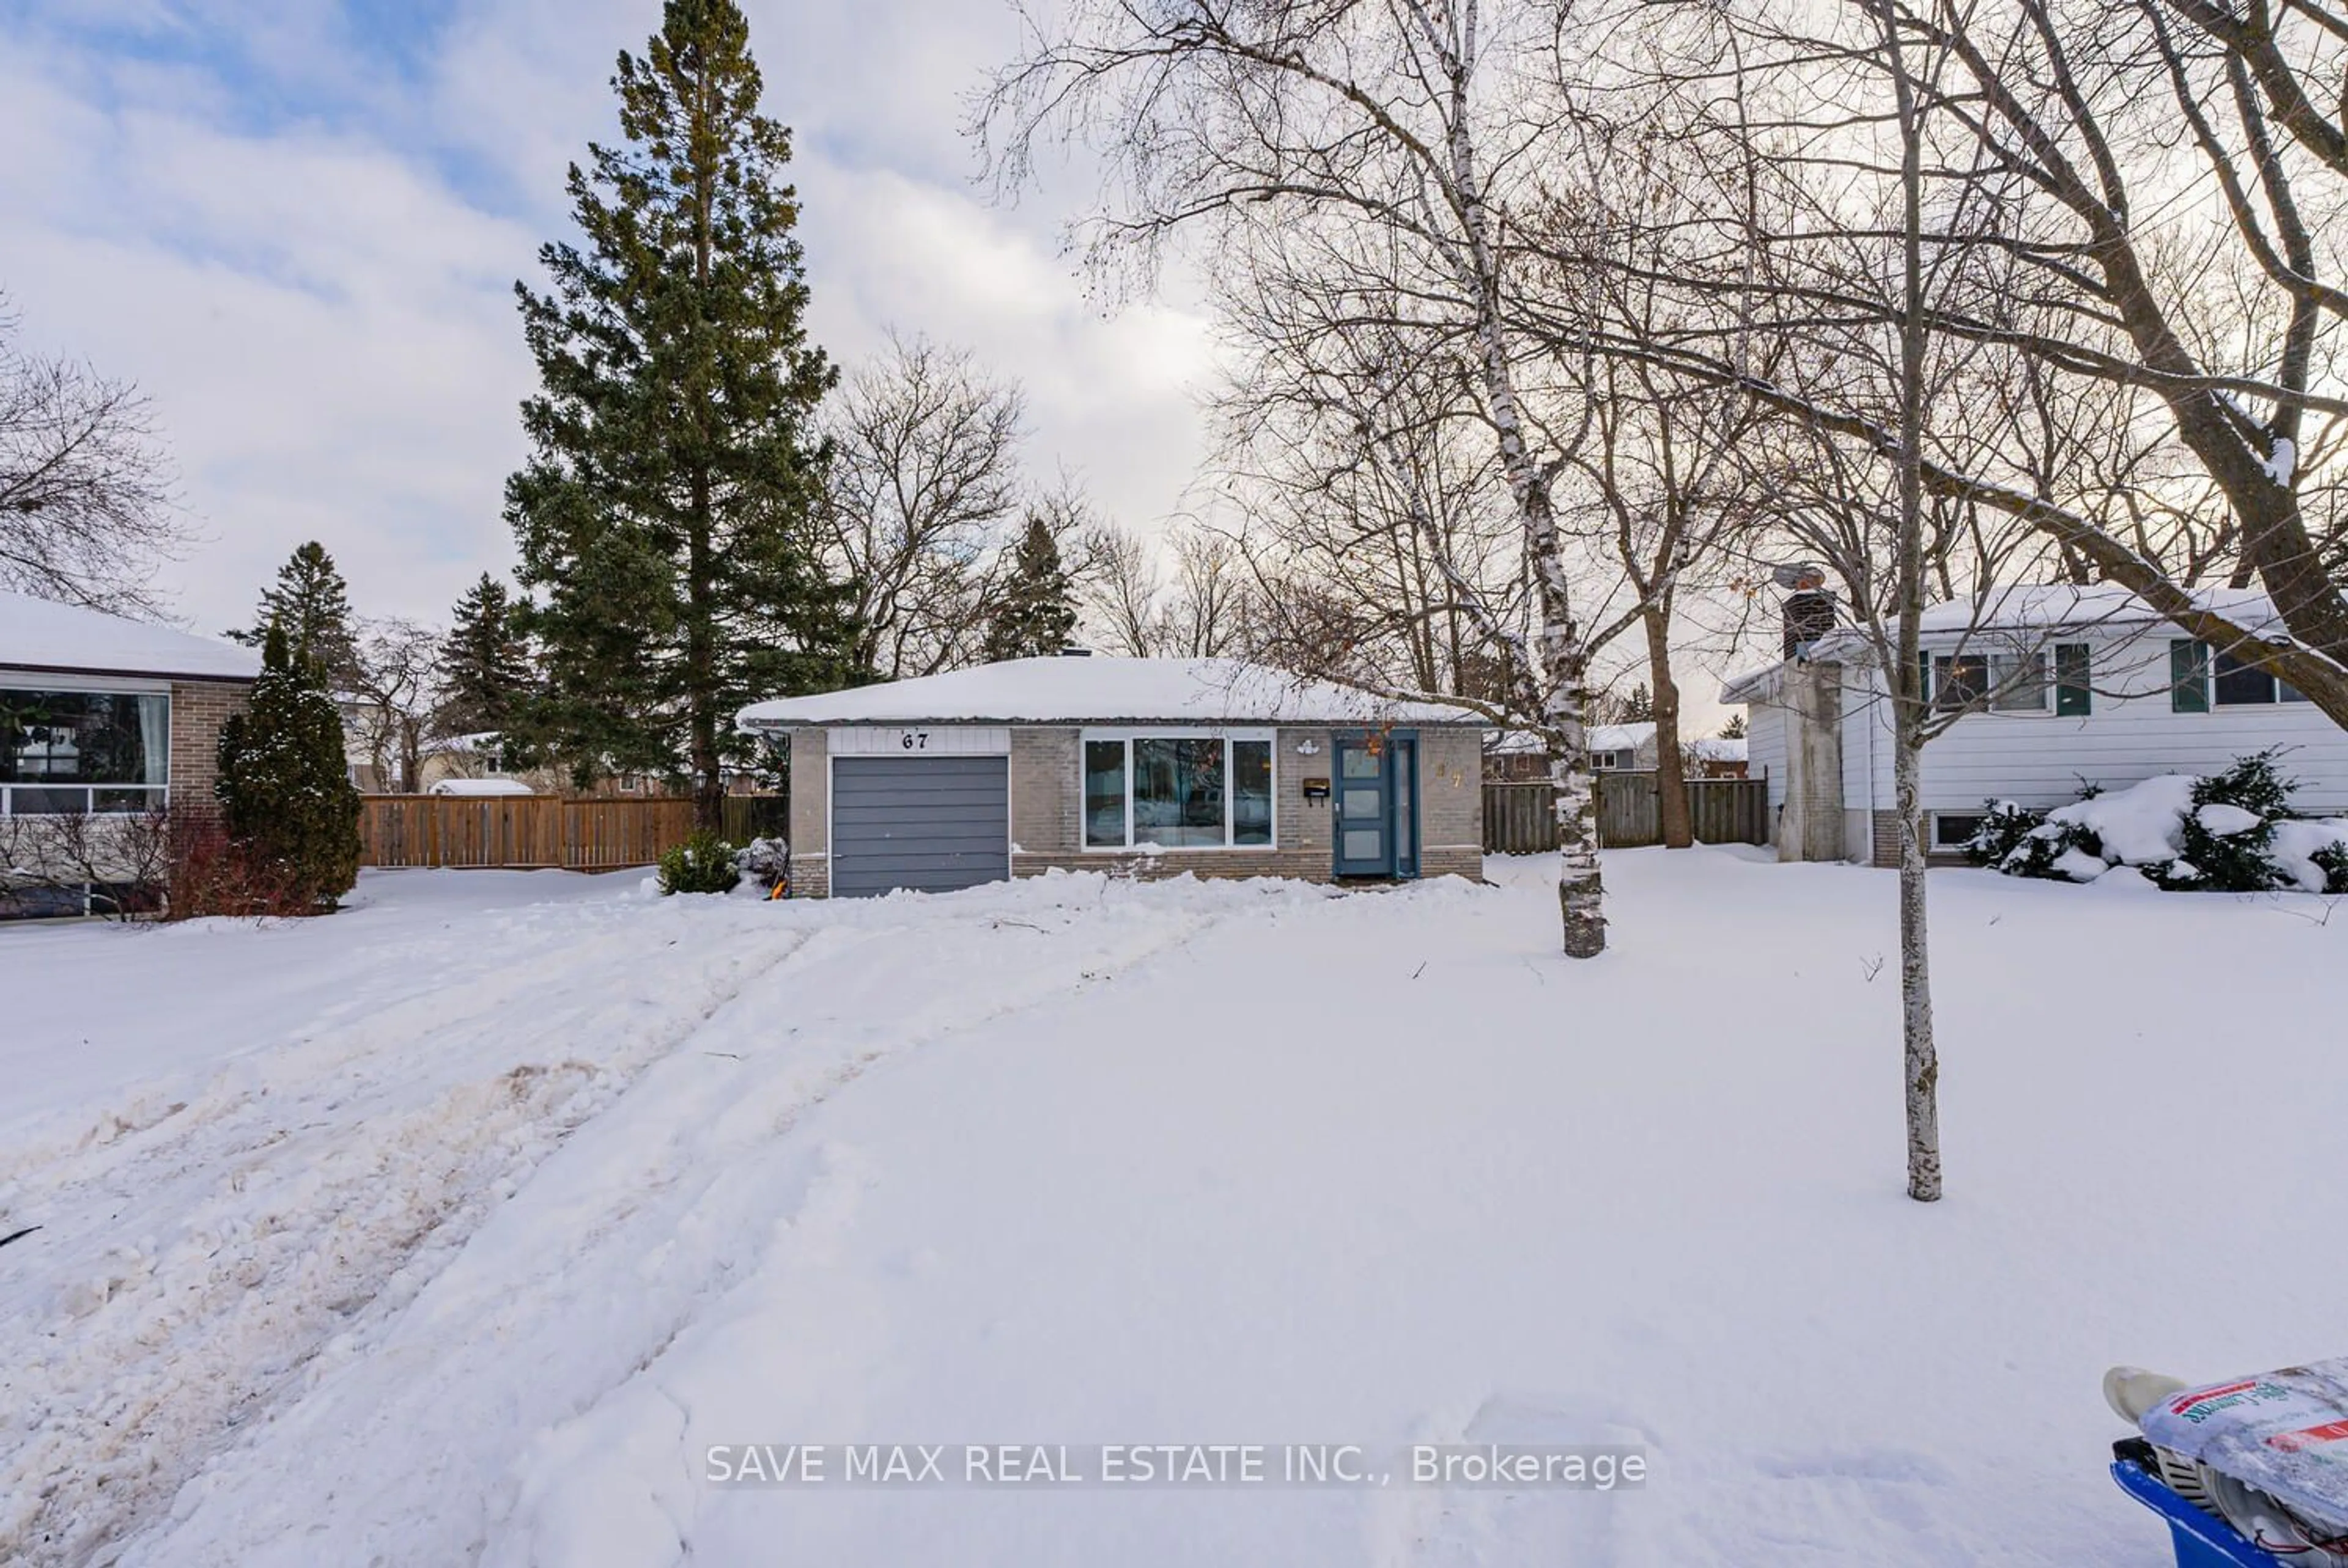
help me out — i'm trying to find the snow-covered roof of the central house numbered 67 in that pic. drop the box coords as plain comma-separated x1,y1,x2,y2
740,655,1482,730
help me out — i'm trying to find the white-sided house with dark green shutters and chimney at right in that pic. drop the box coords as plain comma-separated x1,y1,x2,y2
1721,587,2348,866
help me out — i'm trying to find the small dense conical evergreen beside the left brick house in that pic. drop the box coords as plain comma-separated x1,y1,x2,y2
213,627,360,911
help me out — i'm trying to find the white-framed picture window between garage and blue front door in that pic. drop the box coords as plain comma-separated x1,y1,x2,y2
1085,732,1272,850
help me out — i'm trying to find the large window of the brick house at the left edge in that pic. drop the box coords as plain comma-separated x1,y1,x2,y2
0,690,171,817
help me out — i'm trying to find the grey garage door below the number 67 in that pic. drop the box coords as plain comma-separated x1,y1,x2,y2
831,756,1012,899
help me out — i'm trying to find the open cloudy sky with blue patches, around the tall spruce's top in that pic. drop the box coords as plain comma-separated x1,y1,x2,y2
0,0,1209,631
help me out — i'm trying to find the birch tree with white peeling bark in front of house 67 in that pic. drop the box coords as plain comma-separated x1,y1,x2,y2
975,0,1634,958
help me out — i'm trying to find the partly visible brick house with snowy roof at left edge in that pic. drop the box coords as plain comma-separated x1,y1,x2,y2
0,594,260,916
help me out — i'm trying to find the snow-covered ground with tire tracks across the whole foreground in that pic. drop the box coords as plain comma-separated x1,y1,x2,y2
0,850,2348,1568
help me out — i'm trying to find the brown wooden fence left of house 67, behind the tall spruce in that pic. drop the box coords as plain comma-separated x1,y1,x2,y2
360,796,775,871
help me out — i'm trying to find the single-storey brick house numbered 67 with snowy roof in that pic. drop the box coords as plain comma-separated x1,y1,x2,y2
740,655,1484,897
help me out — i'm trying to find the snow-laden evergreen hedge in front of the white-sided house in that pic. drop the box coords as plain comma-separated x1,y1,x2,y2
1965,751,2348,892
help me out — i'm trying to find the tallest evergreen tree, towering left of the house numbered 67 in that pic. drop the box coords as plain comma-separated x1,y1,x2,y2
505,0,850,828
